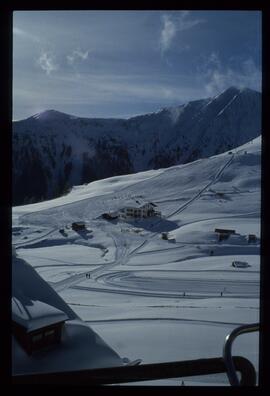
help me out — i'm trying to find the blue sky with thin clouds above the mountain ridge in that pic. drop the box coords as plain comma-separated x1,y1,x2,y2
13,11,261,120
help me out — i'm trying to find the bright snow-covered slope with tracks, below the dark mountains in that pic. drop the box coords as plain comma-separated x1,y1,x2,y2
13,137,261,385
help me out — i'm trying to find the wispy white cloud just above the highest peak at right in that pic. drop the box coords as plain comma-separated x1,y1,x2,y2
197,52,262,95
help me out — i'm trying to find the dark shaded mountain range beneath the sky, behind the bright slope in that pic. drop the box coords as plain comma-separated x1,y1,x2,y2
13,87,261,205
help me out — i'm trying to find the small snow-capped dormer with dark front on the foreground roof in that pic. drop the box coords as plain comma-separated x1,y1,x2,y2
12,297,68,355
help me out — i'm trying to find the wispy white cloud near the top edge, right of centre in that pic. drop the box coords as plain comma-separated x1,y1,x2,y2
160,11,205,53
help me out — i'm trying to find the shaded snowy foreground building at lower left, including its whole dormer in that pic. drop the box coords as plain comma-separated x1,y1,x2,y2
11,255,123,372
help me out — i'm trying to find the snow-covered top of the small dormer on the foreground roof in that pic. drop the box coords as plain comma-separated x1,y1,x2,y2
12,297,68,332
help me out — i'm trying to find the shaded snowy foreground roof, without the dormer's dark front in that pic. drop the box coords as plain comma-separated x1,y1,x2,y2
12,257,122,375
